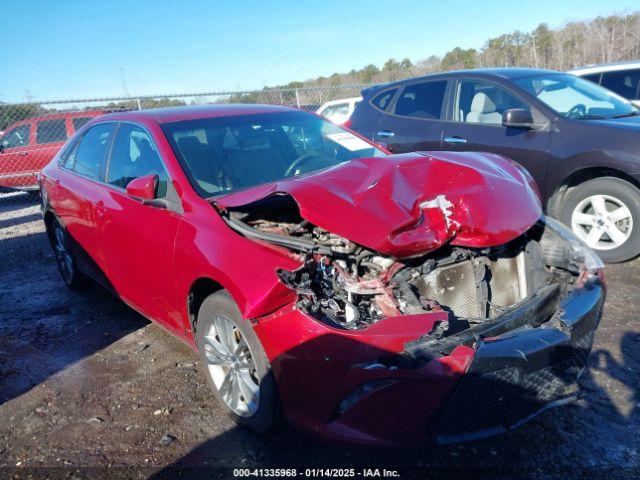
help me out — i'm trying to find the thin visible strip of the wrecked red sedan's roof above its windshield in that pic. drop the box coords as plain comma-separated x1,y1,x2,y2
100,104,301,123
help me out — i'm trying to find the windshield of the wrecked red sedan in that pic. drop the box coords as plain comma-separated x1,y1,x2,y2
162,111,386,198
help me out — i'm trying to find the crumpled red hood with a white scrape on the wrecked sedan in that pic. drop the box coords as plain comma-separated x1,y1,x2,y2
216,152,542,258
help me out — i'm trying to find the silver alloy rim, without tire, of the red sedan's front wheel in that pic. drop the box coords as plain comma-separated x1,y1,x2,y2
204,315,260,417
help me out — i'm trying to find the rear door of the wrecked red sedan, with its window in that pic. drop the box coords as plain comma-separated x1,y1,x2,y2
48,123,115,276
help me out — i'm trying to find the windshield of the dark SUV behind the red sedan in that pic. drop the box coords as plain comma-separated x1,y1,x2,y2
515,74,640,119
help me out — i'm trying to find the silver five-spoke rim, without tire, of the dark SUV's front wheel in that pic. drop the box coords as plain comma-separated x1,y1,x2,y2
571,195,633,250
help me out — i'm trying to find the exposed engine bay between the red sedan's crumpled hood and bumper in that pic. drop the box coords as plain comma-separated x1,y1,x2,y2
221,195,580,336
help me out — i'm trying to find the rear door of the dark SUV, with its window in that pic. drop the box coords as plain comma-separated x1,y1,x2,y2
373,79,448,153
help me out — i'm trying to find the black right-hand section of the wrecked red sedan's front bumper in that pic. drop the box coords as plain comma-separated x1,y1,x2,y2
436,281,605,443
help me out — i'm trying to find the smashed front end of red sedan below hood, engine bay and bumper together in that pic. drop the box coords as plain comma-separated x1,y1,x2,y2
214,153,605,445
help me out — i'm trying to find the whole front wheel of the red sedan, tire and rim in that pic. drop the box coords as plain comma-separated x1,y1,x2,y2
196,290,278,433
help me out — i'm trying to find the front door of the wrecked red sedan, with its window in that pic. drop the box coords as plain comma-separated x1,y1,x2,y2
96,123,183,334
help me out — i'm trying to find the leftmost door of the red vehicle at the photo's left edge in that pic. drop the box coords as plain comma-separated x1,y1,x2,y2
0,122,36,188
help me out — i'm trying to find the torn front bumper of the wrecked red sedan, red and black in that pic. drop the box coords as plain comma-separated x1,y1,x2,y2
254,276,605,446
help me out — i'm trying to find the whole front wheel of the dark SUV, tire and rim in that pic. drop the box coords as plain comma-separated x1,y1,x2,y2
560,177,640,263
